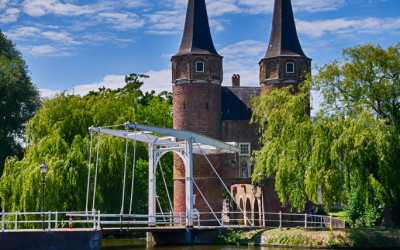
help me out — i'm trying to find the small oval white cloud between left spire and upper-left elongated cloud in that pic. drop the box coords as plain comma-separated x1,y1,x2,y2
98,12,144,30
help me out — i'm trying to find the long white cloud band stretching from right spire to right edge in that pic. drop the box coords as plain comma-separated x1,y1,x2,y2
296,18,400,38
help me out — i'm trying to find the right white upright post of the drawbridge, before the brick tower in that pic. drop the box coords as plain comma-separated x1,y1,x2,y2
184,140,194,227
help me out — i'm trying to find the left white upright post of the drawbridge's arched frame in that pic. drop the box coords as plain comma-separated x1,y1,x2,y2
149,144,157,226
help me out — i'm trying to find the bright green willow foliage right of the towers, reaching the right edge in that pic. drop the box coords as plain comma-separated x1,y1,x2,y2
253,45,400,225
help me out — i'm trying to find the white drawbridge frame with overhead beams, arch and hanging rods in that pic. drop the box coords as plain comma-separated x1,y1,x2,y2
86,122,240,227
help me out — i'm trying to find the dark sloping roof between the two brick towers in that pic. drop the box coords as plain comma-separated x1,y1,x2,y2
221,87,261,121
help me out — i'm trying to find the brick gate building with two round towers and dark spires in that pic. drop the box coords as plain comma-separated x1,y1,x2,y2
171,0,311,219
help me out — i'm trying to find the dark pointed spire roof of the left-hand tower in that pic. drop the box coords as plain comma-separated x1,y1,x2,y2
177,0,219,56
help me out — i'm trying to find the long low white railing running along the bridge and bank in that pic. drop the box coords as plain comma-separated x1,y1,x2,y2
0,211,345,231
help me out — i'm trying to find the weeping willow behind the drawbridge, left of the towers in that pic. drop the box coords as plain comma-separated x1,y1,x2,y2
0,74,172,221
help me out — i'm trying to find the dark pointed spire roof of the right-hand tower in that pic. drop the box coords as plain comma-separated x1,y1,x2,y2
264,0,307,58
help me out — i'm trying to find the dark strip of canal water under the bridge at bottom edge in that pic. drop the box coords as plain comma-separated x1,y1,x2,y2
102,239,287,250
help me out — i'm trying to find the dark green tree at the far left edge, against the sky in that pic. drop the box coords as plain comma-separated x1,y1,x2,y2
0,31,40,176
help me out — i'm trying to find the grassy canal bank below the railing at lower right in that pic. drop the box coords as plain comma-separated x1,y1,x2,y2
217,228,400,248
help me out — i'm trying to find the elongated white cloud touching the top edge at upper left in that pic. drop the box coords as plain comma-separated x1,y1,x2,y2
22,0,96,17
